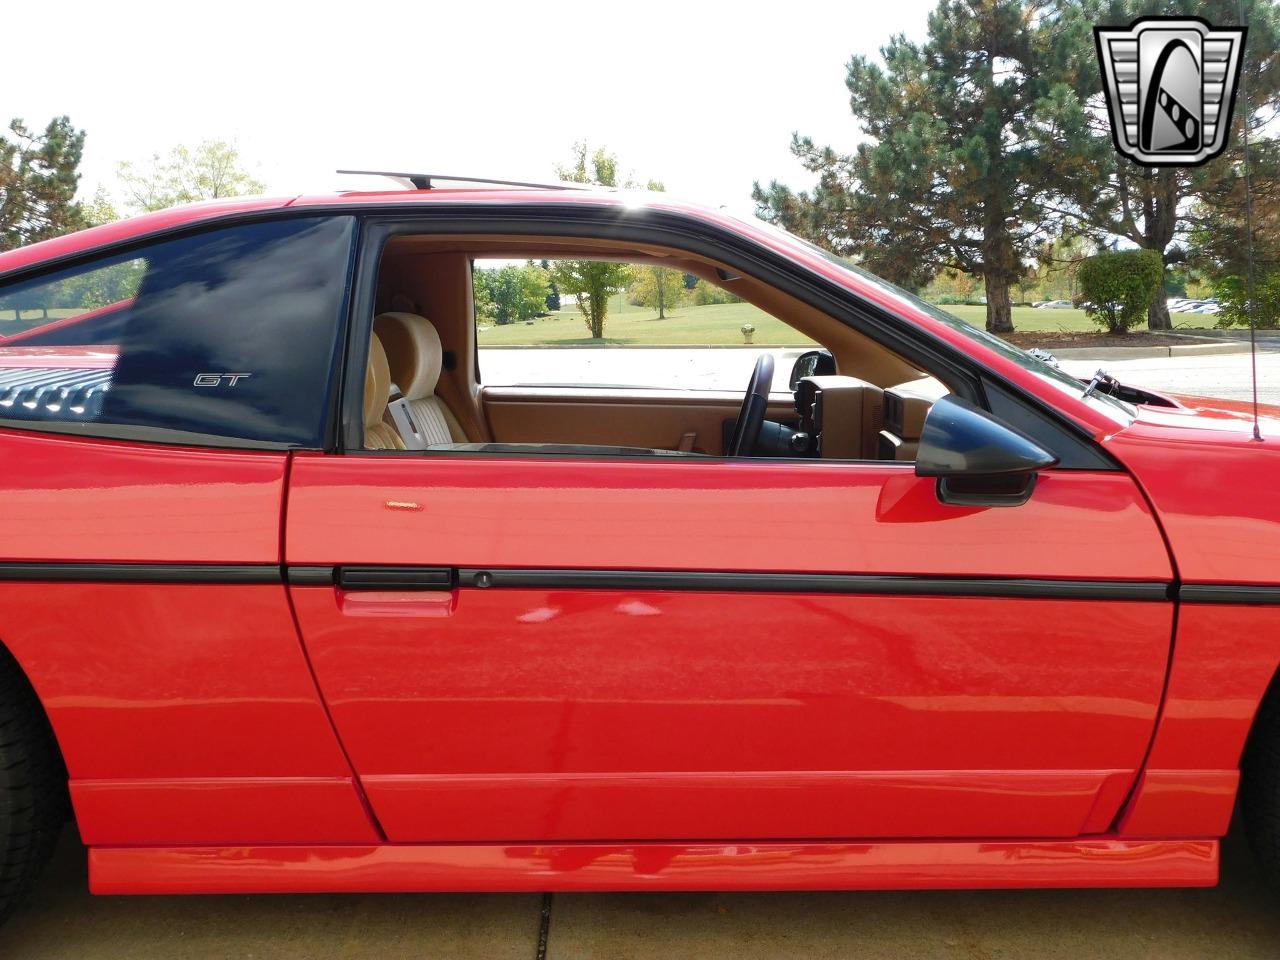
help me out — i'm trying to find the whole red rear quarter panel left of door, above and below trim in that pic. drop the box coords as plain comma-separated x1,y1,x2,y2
0,432,376,842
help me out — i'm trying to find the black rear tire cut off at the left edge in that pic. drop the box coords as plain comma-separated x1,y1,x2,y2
0,646,69,923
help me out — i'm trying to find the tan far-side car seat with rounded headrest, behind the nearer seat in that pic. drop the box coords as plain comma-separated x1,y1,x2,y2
374,312,470,449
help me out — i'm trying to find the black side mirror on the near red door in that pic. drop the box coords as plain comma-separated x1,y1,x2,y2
915,396,1057,507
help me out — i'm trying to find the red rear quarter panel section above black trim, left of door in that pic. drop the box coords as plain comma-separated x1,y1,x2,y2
0,430,285,563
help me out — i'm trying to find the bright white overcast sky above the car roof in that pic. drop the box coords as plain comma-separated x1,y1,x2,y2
0,0,934,207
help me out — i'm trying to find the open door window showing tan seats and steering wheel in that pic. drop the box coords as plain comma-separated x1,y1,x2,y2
362,236,948,462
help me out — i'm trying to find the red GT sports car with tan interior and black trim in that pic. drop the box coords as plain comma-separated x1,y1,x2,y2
0,177,1280,926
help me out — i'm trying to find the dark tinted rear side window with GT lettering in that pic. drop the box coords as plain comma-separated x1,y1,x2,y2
0,218,355,447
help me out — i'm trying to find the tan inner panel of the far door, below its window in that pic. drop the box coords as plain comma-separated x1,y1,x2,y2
481,387,796,456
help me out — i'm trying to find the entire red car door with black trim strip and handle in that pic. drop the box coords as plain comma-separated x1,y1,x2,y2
285,452,1172,842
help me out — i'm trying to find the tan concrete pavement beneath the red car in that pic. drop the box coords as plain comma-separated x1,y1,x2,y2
0,836,1280,960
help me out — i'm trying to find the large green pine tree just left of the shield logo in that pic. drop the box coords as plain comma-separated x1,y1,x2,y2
755,0,1097,333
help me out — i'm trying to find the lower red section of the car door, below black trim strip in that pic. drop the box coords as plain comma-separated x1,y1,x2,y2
292,586,1171,841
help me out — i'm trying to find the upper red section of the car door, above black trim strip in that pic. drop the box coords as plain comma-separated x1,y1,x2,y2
285,453,1172,580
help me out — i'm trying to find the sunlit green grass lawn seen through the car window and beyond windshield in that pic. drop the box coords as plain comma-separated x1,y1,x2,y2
480,297,1098,347
